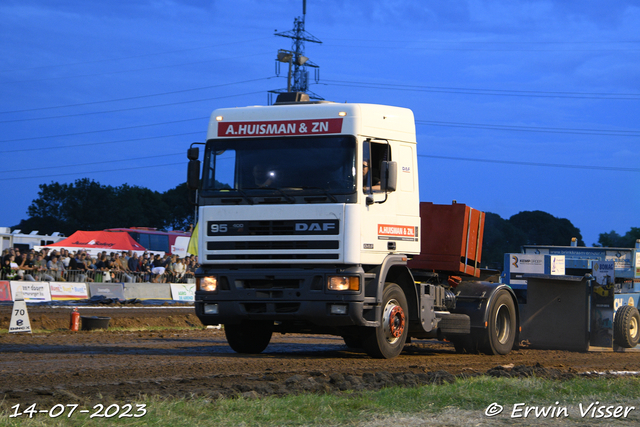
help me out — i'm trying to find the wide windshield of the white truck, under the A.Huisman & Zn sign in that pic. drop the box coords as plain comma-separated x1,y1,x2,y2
202,136,356,195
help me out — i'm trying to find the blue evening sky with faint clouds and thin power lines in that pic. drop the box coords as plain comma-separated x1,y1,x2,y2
0,0,640,245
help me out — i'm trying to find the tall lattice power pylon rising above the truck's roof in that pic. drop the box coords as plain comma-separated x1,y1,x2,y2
269,0,324,103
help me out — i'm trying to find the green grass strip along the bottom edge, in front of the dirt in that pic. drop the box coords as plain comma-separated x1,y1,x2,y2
0,376,640,427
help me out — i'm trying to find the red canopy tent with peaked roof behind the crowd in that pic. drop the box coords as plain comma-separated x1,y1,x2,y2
42,231,146,256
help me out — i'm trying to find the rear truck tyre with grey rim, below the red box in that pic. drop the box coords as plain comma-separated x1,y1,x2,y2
473,289,518,354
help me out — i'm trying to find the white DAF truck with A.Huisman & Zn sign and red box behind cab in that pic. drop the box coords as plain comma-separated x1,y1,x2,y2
188,93,519,358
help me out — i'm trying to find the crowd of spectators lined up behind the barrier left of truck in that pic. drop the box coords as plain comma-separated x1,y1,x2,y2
0,248,198,283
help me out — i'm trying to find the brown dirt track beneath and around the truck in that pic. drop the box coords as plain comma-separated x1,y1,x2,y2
0,306,640,409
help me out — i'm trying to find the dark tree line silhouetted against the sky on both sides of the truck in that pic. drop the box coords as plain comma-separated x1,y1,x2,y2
13,178,640,269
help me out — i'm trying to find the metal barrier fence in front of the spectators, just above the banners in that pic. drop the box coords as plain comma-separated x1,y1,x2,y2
2,270,195,283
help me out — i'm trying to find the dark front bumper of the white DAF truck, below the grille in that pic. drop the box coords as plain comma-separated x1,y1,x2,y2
195,267,376,327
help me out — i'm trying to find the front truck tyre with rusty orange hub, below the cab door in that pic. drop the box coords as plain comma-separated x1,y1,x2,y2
362,283,409,359
